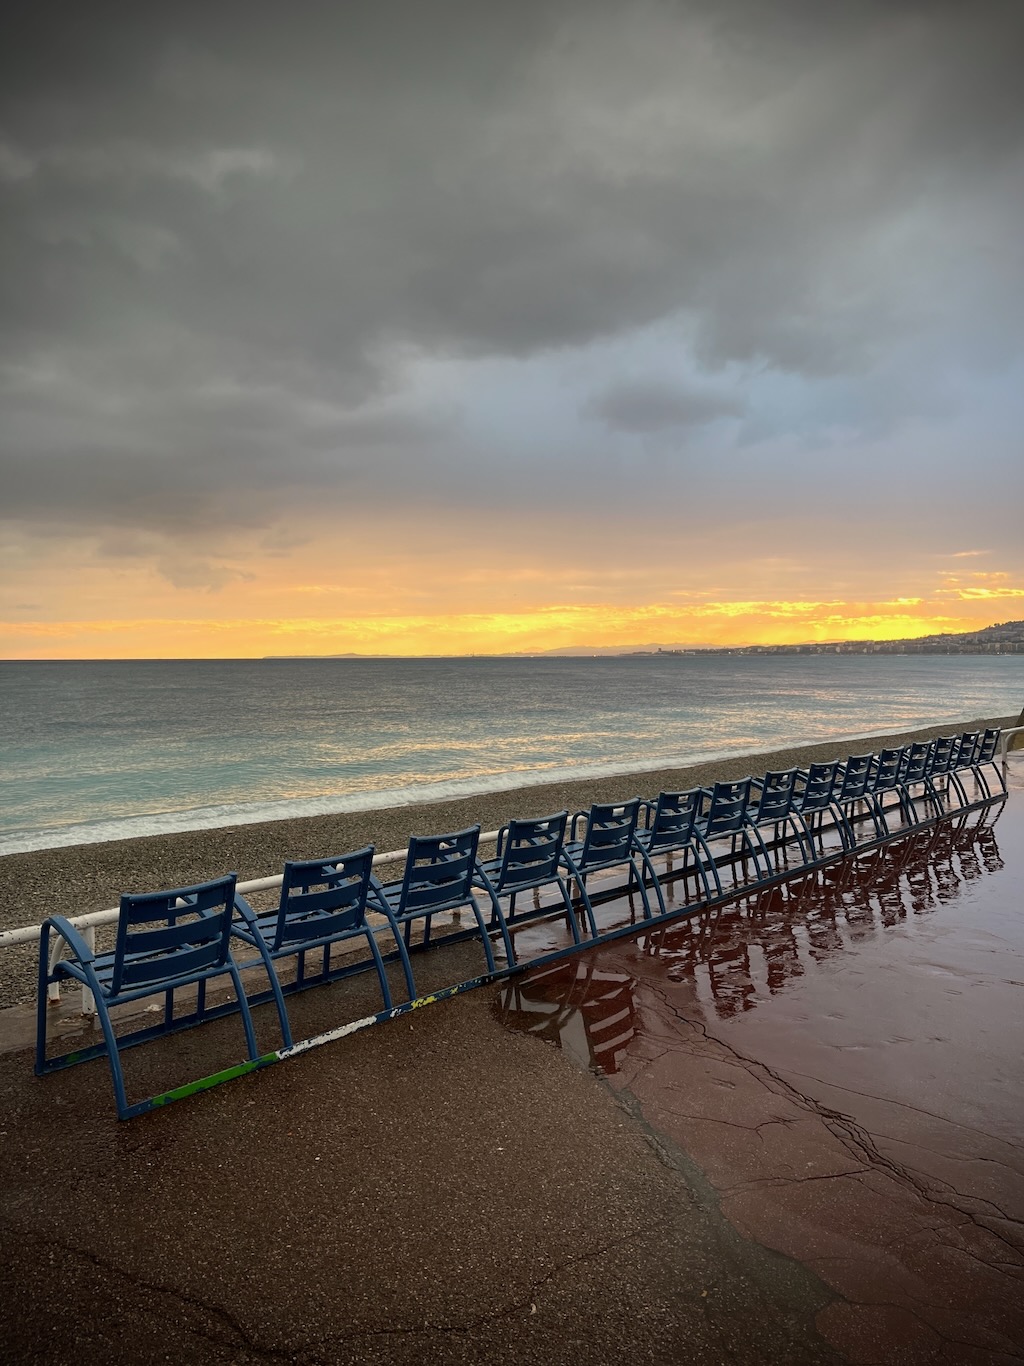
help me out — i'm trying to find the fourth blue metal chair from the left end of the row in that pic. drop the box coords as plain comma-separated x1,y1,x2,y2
477,811,582,963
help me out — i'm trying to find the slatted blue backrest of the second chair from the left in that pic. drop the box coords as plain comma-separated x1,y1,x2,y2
270,844,373,952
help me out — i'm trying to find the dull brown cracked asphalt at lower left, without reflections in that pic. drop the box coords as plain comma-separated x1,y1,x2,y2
0,939,841,1363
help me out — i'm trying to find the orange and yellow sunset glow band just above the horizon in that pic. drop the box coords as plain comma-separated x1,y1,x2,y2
0,523,1024,660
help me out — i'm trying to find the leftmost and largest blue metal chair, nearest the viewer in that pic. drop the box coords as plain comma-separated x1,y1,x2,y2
35,873,259,1119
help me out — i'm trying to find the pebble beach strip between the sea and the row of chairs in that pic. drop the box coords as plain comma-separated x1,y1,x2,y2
0,717,1016,1009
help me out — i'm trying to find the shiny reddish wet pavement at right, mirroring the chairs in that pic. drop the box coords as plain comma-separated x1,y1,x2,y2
497,784,1024,1363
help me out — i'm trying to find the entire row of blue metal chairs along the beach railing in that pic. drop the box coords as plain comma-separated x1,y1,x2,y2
35,731,1005,1119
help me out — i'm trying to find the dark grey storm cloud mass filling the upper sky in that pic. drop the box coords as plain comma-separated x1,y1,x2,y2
0,0,1024,540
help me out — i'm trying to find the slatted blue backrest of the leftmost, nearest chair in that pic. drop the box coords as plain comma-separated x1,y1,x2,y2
111,873,238,996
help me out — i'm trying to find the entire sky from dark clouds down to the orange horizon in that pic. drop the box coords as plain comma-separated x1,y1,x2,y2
0,0,1024,658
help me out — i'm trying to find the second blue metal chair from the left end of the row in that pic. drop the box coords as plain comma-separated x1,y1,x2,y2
233,844,416,1048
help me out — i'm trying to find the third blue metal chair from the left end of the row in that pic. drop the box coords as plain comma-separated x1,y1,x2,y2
374,825,515,974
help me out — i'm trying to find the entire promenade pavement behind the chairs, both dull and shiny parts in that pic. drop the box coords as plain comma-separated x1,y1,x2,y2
0,765,1024,1366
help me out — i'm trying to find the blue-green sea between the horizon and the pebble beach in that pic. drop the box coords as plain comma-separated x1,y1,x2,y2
0,653,1024,854
